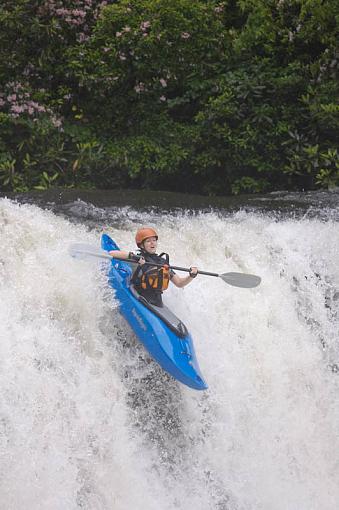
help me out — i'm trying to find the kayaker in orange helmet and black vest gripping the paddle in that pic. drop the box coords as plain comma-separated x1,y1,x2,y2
109,227,198,307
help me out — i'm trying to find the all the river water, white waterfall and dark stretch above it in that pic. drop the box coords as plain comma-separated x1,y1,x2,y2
0,191,339,510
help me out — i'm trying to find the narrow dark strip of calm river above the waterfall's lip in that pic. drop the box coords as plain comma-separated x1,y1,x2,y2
0,189,339,217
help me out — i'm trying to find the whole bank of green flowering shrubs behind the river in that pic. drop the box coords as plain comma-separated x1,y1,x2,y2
0,0,339,194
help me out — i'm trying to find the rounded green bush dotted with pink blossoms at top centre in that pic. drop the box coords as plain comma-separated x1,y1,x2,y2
70,0,229,129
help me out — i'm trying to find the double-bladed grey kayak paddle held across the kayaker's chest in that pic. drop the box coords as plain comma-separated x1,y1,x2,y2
69,243,261,289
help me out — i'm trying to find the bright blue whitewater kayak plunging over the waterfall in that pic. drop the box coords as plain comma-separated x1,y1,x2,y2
101,234,207,390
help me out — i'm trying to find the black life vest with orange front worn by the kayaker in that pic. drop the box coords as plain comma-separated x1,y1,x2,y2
132,250,171,293
